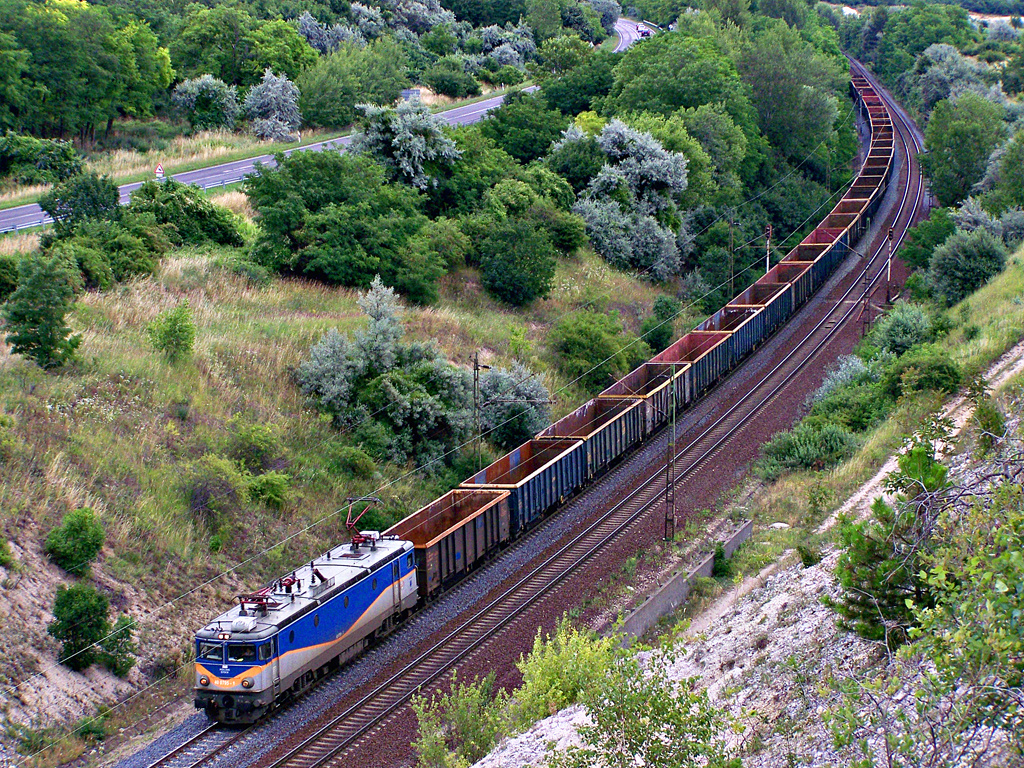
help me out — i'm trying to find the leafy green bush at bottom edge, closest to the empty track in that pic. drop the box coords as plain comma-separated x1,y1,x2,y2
412,672,501,768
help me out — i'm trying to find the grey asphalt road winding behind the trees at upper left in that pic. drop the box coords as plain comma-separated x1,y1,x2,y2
0,18,640,232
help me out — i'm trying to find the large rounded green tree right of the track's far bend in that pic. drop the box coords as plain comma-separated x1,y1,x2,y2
922,93,1004,206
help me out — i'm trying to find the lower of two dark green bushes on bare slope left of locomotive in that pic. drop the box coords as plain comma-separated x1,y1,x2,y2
46,584,111,672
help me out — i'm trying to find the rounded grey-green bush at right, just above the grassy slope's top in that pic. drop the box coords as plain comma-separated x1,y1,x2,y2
929,228,1007,304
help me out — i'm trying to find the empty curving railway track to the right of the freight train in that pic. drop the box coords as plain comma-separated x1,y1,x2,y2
258,62,924,768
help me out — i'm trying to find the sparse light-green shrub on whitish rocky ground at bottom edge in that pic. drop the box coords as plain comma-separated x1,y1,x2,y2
549,653,736,768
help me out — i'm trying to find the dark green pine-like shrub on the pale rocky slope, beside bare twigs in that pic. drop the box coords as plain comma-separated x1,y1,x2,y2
829,439,946,649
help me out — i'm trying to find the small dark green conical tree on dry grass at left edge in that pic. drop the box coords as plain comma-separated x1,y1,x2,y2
2,255,82,369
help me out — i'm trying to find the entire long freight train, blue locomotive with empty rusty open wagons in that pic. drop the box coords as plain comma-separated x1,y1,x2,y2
195,69,894,723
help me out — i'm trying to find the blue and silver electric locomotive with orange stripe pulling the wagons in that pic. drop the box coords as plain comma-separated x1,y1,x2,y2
195,531,418,723
